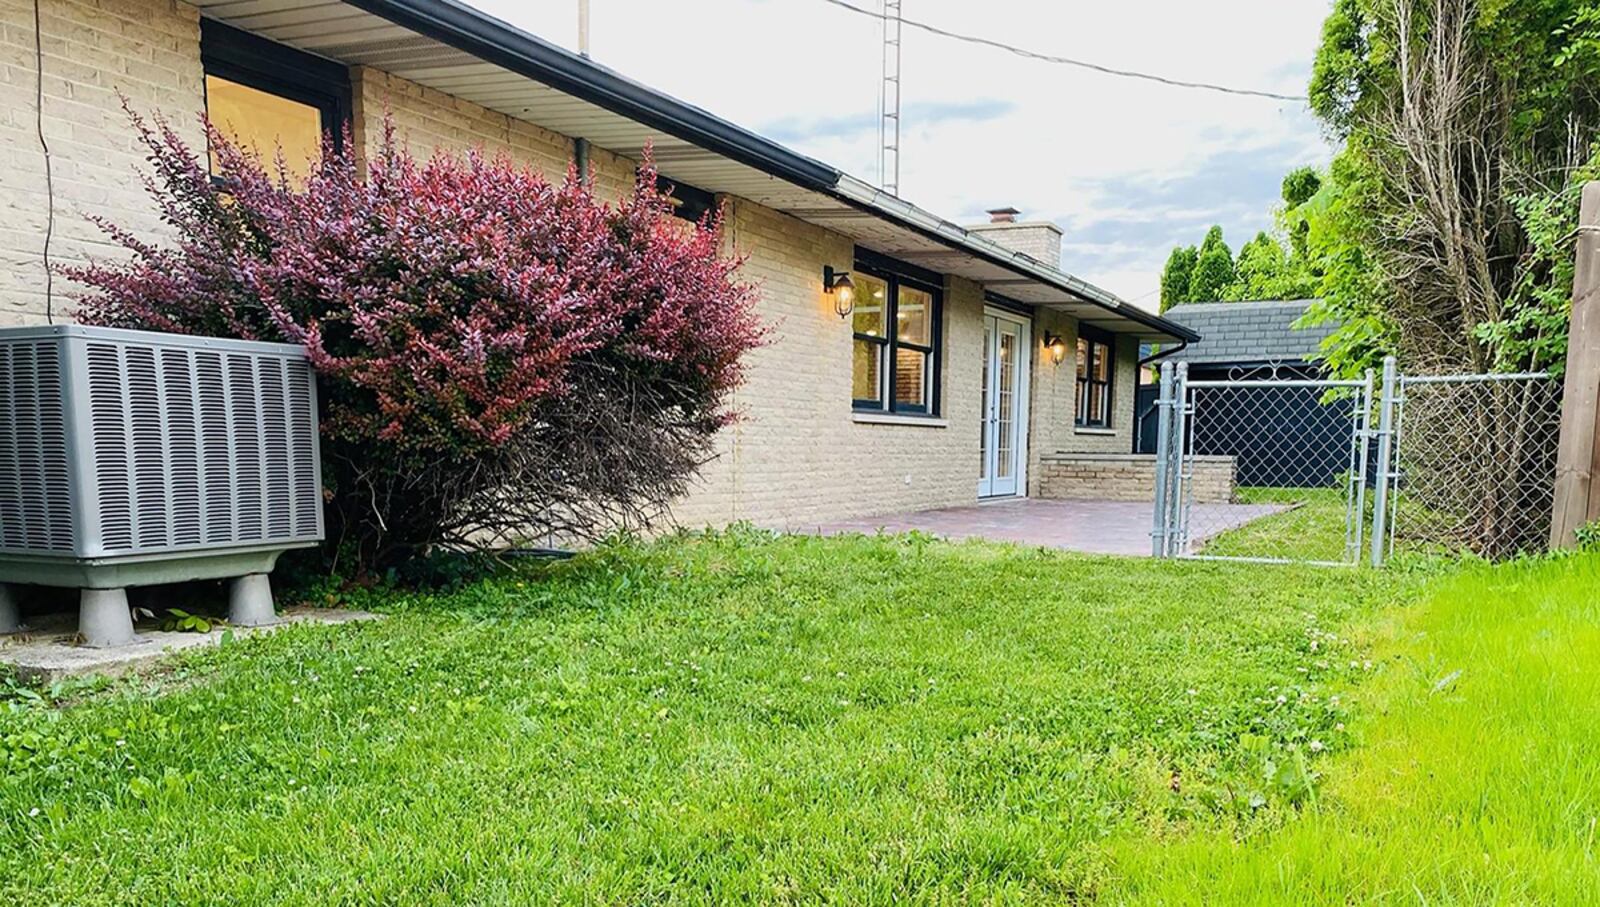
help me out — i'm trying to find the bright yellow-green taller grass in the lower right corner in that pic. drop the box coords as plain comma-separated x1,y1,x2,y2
1107,555,1600,905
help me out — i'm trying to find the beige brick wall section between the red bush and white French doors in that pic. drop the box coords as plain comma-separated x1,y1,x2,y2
674,198,982,528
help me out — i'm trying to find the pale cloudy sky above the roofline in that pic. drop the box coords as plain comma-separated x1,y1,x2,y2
469,0,1330,309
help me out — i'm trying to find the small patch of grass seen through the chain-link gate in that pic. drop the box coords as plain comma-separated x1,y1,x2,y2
1197,488,1371,561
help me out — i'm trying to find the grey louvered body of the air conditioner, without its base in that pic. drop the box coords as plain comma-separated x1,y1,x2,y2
0,325,322,557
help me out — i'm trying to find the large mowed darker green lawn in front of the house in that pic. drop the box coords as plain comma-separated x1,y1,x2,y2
0,531,1401,905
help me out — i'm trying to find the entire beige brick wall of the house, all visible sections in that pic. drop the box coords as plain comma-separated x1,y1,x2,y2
0,0,1136,528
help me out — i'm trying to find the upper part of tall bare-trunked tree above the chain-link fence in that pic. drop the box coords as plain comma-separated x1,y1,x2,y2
1310,0,1600,371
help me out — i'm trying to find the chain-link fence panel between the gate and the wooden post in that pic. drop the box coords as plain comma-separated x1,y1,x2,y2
1389,374,1562,558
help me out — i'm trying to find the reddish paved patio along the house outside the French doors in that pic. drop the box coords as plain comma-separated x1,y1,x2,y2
814,497,1288,555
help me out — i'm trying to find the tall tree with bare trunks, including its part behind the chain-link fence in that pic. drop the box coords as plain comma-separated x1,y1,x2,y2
1306,0,1600,552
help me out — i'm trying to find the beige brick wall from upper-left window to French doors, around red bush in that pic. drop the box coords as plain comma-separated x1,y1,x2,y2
352,67,982,528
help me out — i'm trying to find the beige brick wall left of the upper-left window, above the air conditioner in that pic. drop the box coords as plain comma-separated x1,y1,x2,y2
0,0,203,325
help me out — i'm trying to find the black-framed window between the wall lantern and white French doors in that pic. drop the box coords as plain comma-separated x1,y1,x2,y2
850,254,941,416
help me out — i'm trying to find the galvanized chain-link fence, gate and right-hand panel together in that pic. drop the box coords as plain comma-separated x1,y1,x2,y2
1150,358,1562,566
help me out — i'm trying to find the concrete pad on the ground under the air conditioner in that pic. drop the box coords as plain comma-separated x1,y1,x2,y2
0,608,382,683
